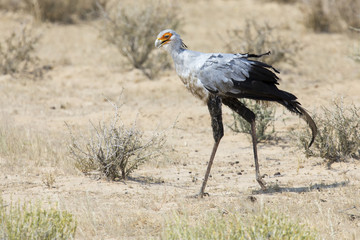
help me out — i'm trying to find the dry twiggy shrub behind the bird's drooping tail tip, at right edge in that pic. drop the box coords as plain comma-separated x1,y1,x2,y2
298,99,360,164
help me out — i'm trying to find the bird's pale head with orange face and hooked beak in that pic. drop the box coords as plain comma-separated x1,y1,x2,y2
155,29,186,51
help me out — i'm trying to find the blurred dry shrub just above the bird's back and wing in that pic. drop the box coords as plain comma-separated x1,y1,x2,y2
225,20,300,65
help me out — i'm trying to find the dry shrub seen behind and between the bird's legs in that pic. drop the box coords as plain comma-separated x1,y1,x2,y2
229,99,275,142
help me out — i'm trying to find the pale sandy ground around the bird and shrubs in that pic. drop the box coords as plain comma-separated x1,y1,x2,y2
0,0,360,239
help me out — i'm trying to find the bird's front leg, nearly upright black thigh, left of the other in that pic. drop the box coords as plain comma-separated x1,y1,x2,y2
199,94,224,197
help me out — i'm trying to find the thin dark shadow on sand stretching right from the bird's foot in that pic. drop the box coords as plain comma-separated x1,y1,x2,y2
252,181,349,194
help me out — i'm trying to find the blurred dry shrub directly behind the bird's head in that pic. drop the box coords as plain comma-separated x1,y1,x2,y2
101,0,180,79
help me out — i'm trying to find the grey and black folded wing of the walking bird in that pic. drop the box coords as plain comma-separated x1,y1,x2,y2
198,54,279,100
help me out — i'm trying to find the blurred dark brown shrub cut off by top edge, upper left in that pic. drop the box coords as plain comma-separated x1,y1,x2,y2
25,0,106,24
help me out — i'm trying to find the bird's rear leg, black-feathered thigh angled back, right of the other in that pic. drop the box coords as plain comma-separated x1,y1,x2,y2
222,98,266,190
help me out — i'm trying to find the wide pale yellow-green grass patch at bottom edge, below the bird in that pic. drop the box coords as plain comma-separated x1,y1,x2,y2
161,211,317,240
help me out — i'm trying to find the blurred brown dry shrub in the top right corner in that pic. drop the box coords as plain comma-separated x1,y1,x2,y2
303,0,360,32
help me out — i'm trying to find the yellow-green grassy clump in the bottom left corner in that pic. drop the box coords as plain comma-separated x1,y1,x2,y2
0,197,77,240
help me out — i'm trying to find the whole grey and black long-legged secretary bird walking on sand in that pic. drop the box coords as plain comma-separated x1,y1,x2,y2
155,29,317,197
